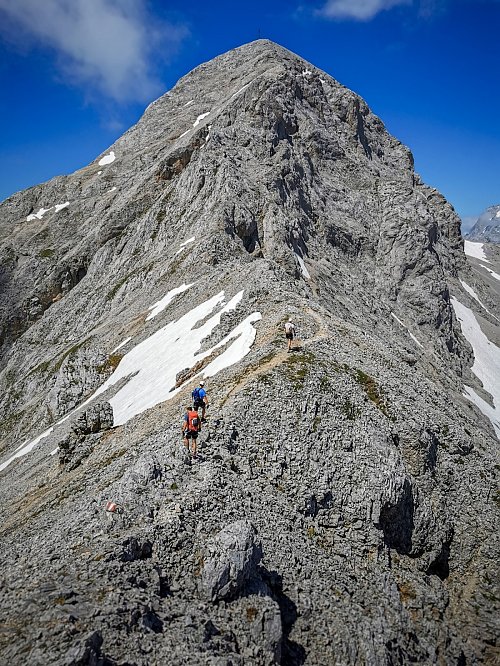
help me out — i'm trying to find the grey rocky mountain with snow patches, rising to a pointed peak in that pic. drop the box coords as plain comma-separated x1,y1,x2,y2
0,40,500,666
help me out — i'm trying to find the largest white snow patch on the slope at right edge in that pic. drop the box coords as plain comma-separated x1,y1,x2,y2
451,296,500,439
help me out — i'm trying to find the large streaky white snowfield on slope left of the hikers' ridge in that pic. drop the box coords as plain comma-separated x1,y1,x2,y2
0,284,262,471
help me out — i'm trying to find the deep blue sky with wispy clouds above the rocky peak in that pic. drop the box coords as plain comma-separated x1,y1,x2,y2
0,0,500,231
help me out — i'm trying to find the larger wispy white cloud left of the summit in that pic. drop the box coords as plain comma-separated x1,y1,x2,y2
0,0,187,102
